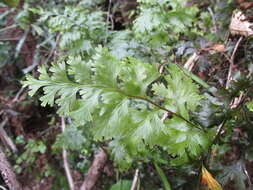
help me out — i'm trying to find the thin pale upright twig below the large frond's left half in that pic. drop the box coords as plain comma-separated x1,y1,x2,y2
61,117,75,190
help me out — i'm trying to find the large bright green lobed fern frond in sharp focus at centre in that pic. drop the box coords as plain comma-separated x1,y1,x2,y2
24,48,209,169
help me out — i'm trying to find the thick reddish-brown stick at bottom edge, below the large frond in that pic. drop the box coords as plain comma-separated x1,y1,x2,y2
80,149,108,190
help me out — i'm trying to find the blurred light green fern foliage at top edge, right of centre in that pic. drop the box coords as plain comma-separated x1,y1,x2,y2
134,0,198,44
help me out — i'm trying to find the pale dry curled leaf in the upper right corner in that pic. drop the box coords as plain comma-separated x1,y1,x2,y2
229,11,253,36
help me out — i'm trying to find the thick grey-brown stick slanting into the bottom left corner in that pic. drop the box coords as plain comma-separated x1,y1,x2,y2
0,146,23,190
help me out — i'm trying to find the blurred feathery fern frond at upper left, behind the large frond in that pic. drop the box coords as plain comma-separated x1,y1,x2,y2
39,6,107,53
